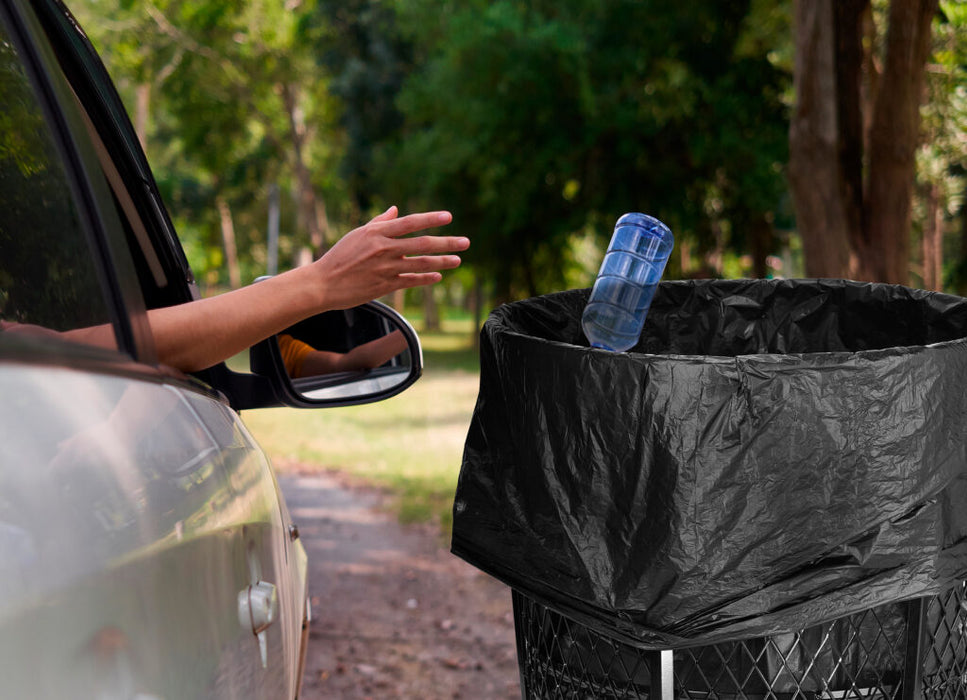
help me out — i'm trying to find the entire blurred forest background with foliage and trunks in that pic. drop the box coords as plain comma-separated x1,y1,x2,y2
70,0,967,329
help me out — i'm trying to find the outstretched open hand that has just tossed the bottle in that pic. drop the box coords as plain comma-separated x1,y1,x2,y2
313,207,470,309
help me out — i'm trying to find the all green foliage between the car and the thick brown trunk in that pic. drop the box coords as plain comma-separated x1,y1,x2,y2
64,0,791,299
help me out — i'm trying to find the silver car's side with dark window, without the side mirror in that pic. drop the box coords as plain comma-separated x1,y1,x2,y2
0,0,306,698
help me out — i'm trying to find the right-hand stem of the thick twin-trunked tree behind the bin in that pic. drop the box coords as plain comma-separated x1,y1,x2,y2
864,0,939,284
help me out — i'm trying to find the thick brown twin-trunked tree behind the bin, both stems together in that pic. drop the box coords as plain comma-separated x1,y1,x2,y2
789,0,939,284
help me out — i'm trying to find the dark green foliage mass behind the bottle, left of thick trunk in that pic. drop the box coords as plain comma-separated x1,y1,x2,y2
381,0,789,297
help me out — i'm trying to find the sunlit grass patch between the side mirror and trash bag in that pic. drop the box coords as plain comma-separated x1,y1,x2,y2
243,319,479,530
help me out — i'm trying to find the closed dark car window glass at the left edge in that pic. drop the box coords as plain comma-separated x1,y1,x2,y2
0,24,113,343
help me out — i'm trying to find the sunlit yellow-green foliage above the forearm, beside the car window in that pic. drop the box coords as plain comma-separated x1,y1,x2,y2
74,0,341,283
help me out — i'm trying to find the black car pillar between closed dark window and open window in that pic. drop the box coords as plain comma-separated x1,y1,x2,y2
0,0,157,364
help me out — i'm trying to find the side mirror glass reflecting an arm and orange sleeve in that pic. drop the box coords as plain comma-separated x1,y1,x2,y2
276,302,419,401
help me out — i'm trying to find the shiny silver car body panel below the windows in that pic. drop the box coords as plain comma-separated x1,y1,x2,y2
0,348,306,699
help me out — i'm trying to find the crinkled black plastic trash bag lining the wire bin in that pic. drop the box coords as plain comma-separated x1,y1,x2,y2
452,280,967,649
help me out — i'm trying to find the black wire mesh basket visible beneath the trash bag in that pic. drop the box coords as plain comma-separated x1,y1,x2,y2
514,583,967,700
